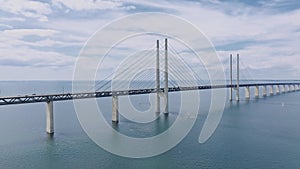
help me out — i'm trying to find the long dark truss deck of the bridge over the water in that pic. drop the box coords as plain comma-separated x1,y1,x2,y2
0,83,300,105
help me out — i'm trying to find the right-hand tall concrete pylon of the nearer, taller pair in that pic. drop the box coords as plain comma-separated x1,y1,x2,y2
164,39,169,114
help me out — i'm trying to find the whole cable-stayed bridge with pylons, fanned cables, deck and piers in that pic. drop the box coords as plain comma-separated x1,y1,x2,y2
0,39,300,134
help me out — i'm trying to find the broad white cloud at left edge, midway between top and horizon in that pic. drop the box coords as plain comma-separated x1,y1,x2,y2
0,29,78,77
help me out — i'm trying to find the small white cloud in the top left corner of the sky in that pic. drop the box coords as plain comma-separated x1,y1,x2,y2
0,0,52,21
